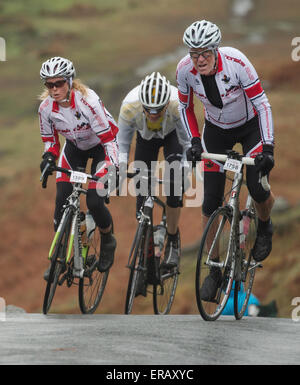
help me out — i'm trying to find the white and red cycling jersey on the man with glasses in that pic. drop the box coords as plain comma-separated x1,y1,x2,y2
176,47,274,145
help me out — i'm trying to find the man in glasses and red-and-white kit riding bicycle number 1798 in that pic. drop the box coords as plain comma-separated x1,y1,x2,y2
177,20,274,298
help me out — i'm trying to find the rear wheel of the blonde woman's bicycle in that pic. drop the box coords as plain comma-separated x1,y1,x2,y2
78,227,109,314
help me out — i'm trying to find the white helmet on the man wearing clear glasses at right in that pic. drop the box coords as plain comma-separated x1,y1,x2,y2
183,20,221,49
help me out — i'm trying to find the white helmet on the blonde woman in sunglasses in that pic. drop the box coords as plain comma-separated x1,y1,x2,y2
40,56,76,79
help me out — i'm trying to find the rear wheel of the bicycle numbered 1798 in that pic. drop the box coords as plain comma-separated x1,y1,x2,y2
234,203,257,320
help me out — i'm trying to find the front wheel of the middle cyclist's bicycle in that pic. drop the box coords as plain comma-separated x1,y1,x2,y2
125,223,147,314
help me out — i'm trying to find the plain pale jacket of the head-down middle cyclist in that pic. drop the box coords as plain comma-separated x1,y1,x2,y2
117,86,190,161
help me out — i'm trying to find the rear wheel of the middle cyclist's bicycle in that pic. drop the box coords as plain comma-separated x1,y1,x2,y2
153,230,181,315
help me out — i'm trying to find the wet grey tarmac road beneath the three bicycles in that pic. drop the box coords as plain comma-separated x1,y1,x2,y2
0,313,300,365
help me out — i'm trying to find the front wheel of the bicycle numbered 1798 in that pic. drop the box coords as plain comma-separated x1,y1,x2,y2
195,207,235,321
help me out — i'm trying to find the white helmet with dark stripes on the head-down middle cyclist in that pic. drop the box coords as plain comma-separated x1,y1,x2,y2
139,72,171,113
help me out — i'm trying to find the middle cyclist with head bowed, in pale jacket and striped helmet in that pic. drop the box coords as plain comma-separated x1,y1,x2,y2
117,72,190,268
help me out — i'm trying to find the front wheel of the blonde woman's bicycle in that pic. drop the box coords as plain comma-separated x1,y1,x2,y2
43,209,72,314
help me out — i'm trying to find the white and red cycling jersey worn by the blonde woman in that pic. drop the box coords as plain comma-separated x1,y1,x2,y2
39,89,118,165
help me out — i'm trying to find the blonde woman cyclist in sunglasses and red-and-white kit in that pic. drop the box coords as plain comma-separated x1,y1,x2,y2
39,57,118,280
